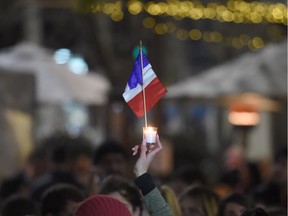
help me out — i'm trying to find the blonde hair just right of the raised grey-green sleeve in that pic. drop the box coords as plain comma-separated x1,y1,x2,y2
160,185,182,216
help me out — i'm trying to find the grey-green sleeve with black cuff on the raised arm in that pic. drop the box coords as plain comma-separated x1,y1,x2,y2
135,173,173,216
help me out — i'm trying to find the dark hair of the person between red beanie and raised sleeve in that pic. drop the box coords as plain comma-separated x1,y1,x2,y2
98,176,143,212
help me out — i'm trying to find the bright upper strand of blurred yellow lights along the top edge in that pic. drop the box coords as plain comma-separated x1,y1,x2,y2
91,0,287,25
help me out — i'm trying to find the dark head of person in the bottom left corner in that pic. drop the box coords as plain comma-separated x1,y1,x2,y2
0,195,40,216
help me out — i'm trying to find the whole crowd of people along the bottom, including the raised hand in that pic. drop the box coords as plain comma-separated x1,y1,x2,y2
0,134,287,216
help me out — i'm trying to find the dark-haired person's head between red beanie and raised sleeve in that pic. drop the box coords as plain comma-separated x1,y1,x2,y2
98,176,143,216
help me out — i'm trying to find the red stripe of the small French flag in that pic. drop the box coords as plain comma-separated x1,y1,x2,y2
128,77,167,118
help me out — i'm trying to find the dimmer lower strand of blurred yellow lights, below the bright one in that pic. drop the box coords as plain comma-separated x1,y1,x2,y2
143,17,284,50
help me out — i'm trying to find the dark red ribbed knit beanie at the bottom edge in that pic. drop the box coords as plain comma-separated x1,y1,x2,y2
74,194,132,216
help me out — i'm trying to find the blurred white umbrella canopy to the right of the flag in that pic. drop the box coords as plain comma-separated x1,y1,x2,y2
166,41,287,98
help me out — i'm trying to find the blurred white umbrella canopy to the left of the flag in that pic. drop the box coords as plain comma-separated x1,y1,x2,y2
0,43,110,105
